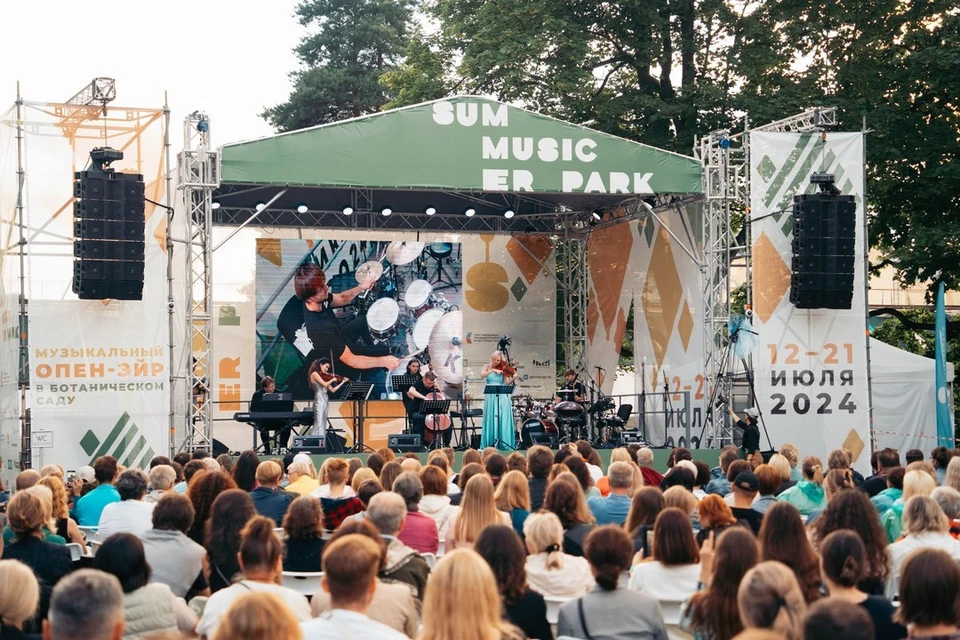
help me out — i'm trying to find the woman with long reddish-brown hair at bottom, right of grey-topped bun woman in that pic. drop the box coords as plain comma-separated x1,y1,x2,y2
680,524,759,640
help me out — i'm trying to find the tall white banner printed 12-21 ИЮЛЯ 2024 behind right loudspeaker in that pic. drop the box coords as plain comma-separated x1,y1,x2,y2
750,132,870,472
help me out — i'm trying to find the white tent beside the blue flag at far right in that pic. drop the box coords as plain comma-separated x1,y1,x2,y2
870,338,954,456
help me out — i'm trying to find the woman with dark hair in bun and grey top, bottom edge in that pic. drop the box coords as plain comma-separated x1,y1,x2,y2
557,525,668,640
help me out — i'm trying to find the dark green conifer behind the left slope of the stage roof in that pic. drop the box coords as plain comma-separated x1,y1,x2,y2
261,0,414,131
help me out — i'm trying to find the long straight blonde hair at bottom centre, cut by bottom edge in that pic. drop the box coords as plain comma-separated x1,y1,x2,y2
418,548,515,640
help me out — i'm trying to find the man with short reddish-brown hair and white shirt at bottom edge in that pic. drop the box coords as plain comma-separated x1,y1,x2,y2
301,533,407,640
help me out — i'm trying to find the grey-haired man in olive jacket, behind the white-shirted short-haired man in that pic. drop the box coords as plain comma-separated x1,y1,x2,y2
367,492,430,601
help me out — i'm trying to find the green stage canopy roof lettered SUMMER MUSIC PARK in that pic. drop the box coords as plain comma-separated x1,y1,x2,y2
214,96,701,232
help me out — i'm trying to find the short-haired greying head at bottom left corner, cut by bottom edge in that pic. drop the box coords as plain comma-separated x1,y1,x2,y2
43,569,124,640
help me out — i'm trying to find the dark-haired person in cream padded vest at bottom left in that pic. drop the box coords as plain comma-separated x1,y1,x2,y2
93,532,197,637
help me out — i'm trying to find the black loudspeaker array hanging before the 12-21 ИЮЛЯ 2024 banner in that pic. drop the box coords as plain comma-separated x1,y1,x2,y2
790,193,857,309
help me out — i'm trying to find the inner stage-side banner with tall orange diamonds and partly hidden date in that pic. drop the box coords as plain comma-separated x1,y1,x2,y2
631,204,708,447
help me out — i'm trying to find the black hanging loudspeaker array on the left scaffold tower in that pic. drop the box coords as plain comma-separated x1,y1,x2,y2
73,170,145,300
